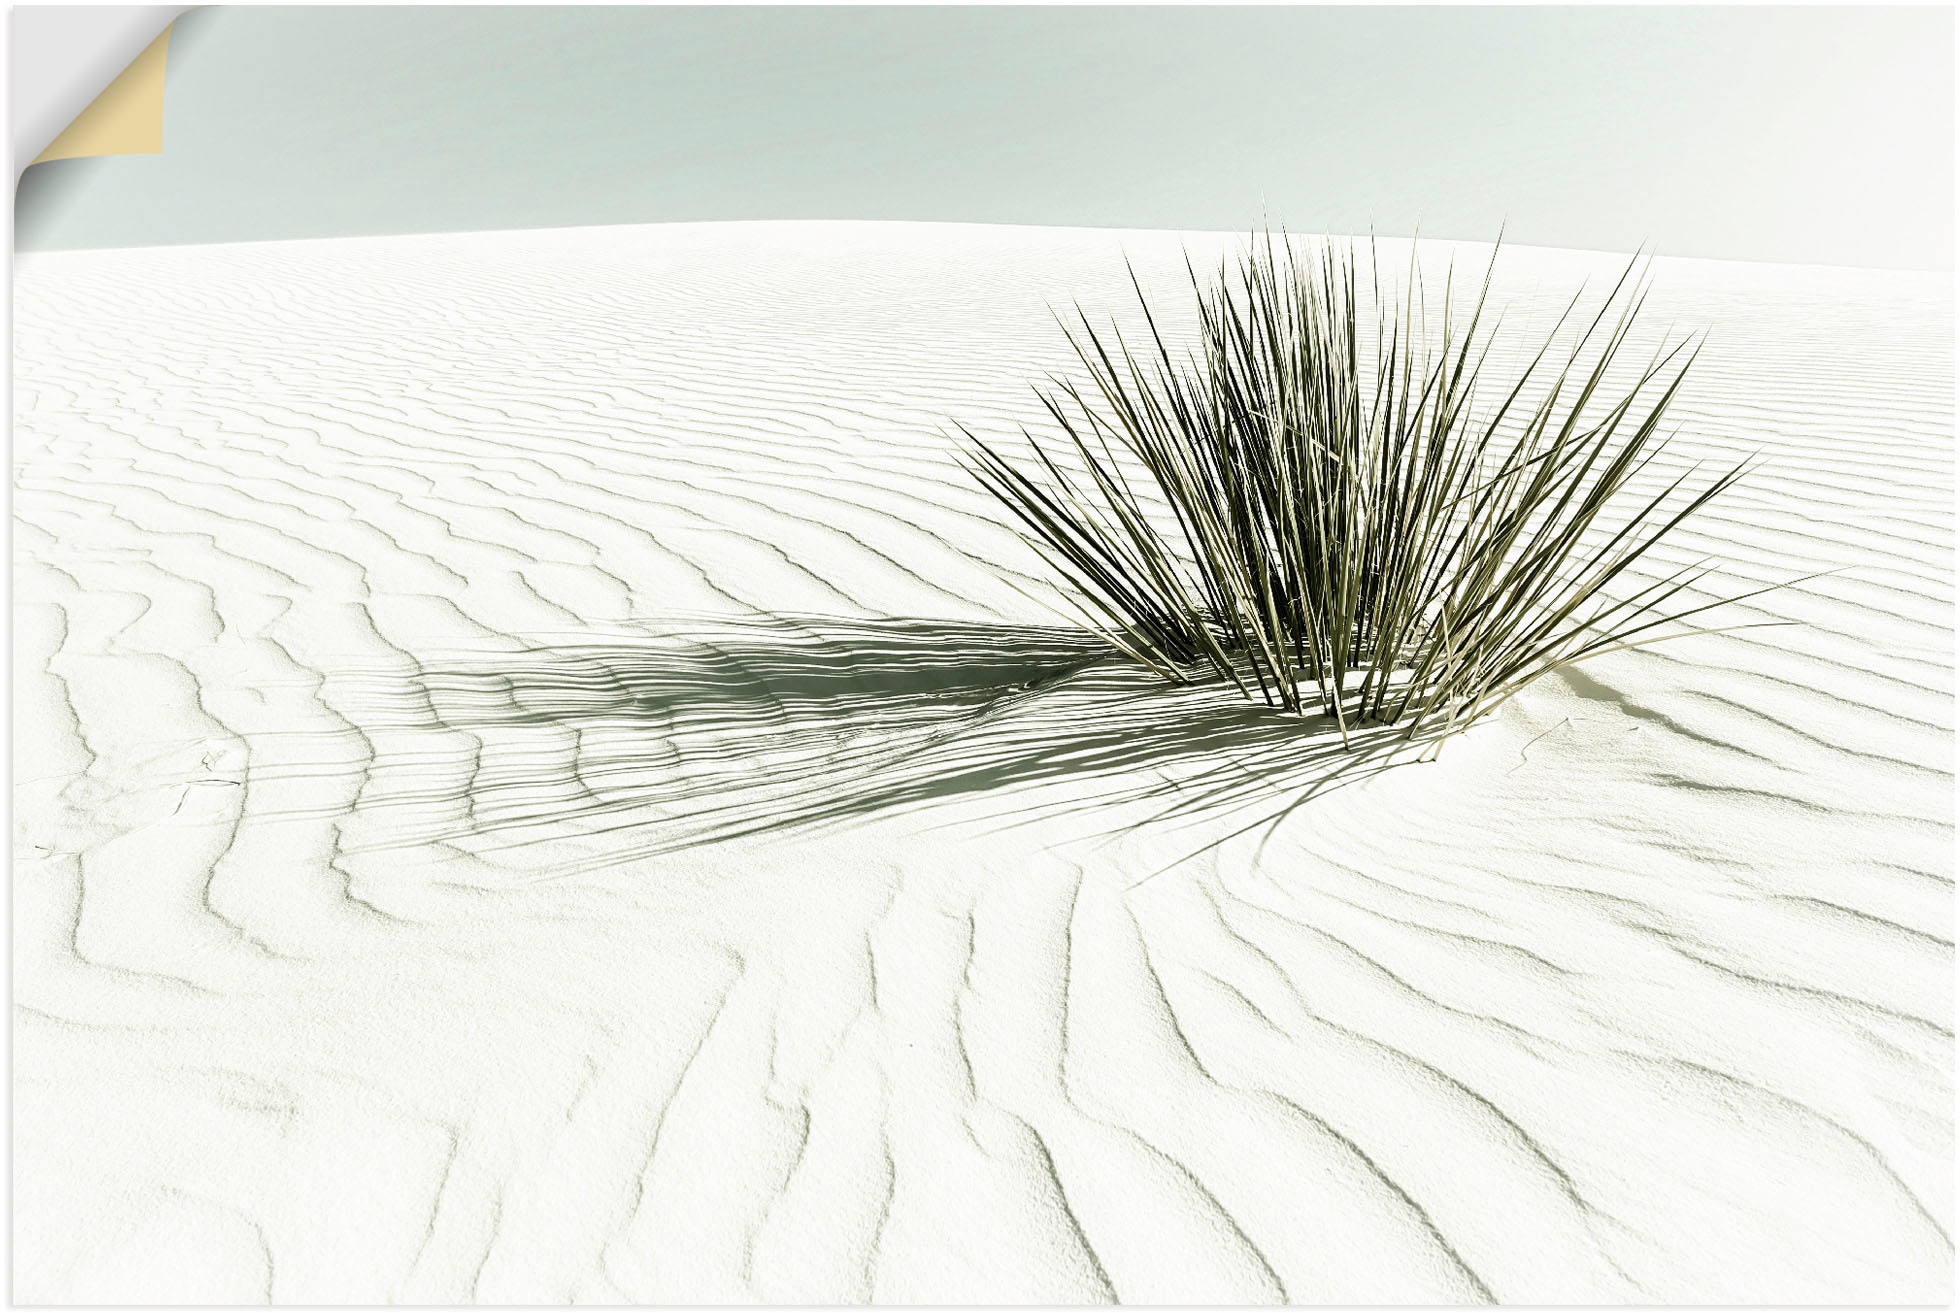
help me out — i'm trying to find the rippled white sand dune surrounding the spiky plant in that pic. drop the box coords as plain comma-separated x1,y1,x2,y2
14,223,1954,1303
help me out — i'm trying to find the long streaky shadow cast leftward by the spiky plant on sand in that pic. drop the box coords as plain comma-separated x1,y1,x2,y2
343,617,1442,874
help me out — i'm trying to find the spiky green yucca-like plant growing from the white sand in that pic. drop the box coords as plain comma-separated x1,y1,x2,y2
960,233,1779,752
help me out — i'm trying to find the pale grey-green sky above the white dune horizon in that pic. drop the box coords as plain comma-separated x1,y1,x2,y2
16,6,1954,268
